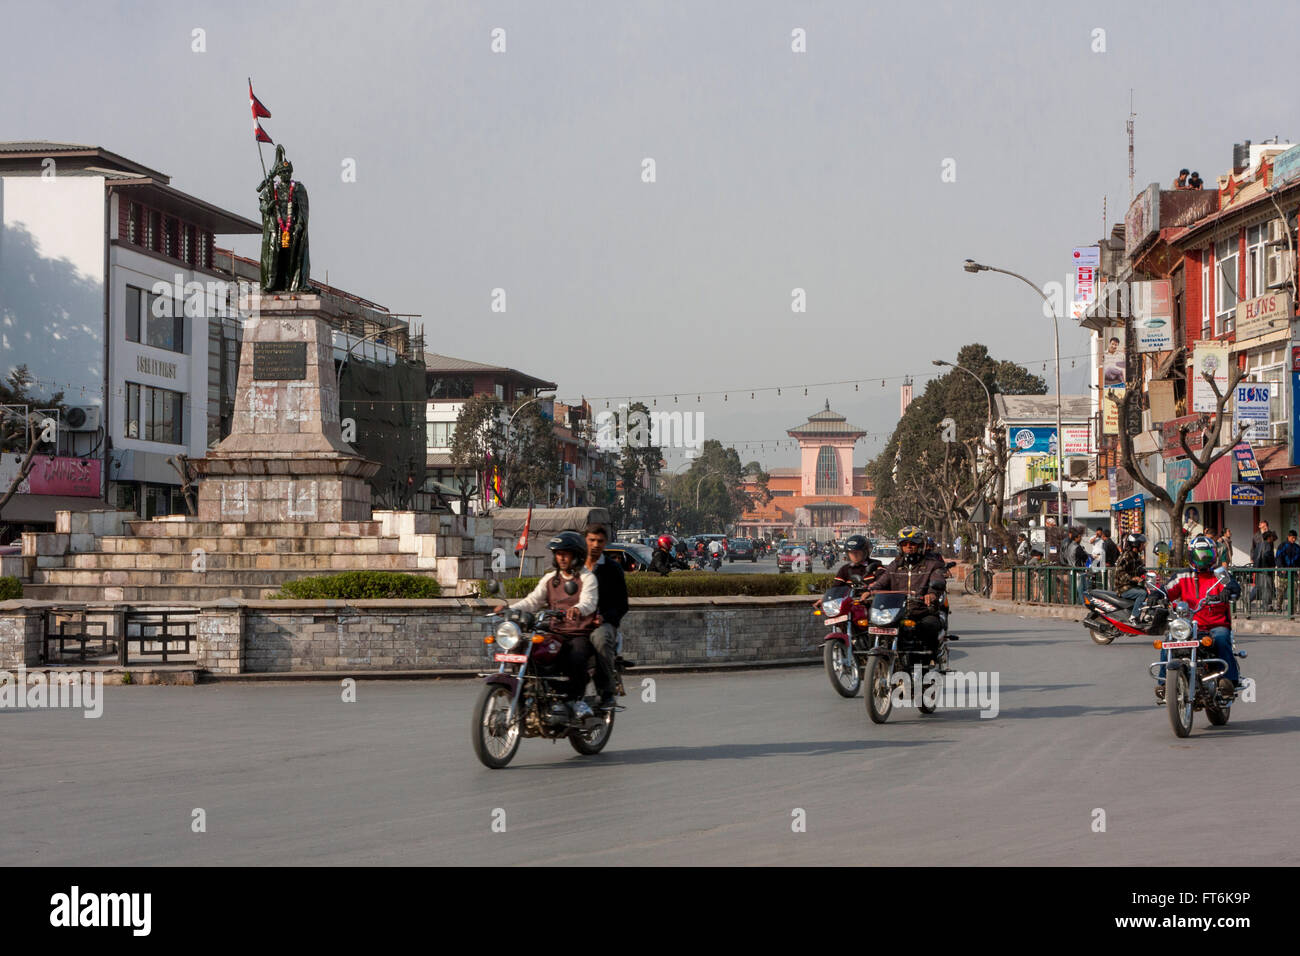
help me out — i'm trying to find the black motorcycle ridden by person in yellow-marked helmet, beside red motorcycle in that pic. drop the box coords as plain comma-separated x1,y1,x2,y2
866,591,958,723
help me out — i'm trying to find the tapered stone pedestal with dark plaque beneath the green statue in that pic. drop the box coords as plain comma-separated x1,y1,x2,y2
195,295,380,522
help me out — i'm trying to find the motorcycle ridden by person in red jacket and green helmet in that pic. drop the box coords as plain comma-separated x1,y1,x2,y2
1147,567,1245,737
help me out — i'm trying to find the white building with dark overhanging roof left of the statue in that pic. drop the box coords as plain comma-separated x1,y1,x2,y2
0,142,261,524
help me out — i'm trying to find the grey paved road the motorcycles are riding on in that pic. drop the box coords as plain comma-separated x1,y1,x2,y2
0,614,1300,865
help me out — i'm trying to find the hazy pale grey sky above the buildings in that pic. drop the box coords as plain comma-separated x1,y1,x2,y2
0,0,1300,467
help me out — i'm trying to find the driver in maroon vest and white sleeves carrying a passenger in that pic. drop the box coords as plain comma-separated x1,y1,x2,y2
497,531,601,717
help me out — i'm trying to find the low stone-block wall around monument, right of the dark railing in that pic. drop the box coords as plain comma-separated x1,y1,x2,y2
199,597,826,674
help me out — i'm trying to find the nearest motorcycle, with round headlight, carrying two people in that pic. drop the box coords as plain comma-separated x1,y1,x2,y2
471,610,633,770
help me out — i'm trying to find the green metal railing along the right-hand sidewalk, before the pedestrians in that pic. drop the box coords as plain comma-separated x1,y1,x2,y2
1009,564,1300,619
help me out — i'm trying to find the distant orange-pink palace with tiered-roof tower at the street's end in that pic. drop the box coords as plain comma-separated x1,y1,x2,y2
736,402,876,540
